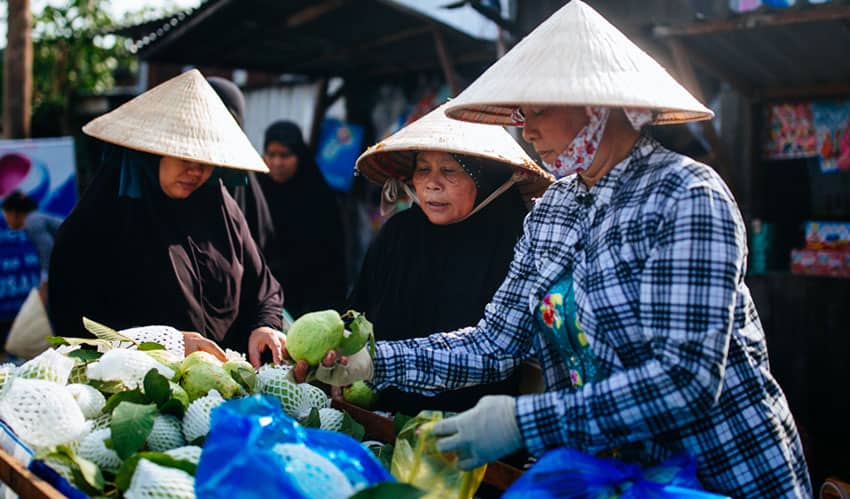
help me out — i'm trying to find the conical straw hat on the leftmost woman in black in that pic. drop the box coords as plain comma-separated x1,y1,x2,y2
83,69,269,173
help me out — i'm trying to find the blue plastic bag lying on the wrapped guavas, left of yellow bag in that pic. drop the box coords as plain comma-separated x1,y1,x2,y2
195,395,394,499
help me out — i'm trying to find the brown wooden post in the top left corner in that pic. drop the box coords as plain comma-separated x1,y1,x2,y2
3,0,32,139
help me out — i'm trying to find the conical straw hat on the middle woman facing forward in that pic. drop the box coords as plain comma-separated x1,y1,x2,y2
357,104,555,199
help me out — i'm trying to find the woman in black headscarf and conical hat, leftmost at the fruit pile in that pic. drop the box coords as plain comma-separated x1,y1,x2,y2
49,70,283,364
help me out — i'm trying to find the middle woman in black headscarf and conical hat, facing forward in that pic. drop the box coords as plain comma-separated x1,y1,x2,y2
349,103,553,415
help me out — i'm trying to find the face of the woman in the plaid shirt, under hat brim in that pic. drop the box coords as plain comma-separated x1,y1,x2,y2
520,106,588,164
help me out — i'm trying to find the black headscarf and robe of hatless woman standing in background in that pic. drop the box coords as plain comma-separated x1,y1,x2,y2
259,121,346,317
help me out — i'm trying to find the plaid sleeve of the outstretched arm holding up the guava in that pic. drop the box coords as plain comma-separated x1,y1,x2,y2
372,212,534,395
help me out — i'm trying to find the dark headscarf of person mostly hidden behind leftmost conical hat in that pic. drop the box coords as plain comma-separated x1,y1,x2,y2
207,76,274,262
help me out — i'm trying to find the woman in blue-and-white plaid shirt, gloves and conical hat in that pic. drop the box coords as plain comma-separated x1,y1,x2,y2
294,0,811,497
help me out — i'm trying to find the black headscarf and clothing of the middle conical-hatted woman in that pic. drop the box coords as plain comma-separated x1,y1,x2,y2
349,161,526,415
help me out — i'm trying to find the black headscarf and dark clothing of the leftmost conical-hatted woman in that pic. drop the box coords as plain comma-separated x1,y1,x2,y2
49,146,283,352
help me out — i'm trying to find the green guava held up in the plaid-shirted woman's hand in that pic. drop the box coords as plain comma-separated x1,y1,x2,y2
286,310,345,366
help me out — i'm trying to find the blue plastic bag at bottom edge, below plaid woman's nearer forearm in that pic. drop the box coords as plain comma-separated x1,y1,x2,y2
502,448,725,499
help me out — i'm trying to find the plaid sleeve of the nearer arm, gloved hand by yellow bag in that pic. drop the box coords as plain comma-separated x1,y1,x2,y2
516,179,746,454
